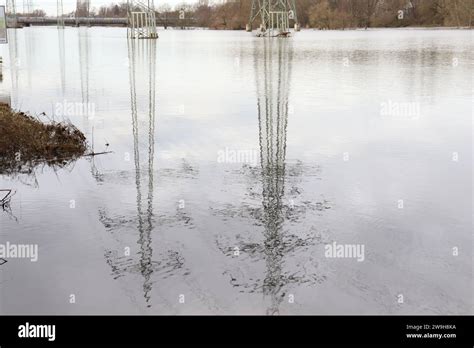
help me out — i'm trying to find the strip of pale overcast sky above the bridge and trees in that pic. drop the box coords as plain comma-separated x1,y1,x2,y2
0,0,197,15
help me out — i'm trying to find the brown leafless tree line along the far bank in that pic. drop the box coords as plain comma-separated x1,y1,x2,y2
15,0,474,30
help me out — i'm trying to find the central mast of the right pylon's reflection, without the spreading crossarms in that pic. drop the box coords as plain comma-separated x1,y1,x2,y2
255,40,292,314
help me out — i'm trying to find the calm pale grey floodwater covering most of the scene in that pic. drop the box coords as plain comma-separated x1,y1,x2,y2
0,27,474,314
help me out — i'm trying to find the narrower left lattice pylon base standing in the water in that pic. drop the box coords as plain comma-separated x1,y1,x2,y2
127,0,158,39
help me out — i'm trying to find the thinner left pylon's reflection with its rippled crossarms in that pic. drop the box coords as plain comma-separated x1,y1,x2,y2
99,40,187,308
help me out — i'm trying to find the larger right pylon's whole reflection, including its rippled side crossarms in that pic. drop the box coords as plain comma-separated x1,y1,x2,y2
213,38,330,315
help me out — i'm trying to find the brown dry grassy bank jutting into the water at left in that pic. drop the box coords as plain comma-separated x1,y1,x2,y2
0,104,87,174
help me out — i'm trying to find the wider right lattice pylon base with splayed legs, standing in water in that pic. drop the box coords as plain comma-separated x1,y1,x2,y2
247,0,300,37
